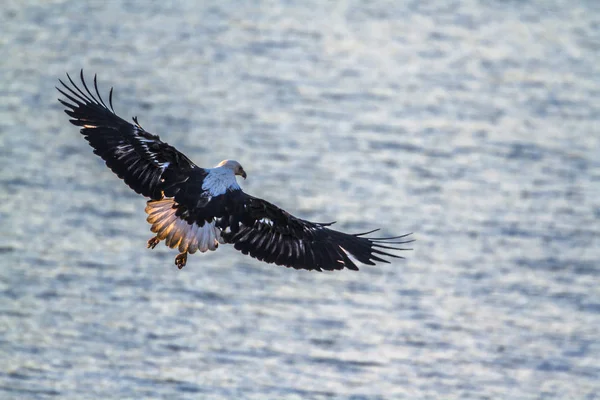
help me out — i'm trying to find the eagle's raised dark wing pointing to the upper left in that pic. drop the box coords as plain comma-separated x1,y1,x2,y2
56,70,197,199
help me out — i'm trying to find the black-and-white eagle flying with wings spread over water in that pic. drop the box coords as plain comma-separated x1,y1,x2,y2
56,70,413,271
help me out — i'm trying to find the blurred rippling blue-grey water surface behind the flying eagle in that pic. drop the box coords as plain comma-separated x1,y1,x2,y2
0,0,600,399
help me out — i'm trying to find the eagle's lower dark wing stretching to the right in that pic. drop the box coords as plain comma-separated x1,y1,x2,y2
221,191,413,271
